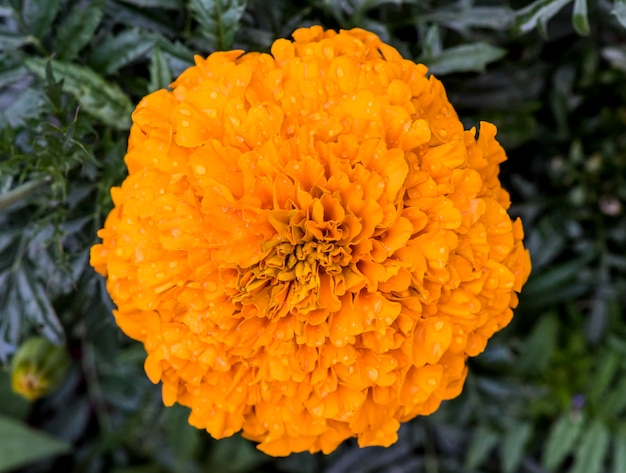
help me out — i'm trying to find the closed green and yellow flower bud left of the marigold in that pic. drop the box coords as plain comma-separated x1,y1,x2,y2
11,337,69,401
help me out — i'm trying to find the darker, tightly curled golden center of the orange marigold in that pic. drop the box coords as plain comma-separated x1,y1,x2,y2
232,190,360,317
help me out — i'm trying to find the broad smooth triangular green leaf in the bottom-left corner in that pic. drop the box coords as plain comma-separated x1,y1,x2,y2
0,414,70,472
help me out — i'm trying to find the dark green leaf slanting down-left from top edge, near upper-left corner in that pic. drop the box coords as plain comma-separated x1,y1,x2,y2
55,2,104,60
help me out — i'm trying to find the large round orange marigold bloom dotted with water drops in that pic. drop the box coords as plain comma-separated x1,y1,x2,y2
91,26,530,455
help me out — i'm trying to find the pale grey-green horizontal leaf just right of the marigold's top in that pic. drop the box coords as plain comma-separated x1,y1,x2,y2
423,41,506,75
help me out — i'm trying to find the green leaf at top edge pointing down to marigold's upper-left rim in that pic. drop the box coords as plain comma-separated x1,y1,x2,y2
189,0,248,51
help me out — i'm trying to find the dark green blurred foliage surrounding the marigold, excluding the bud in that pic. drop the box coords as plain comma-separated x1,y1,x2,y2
0,0,626,473
